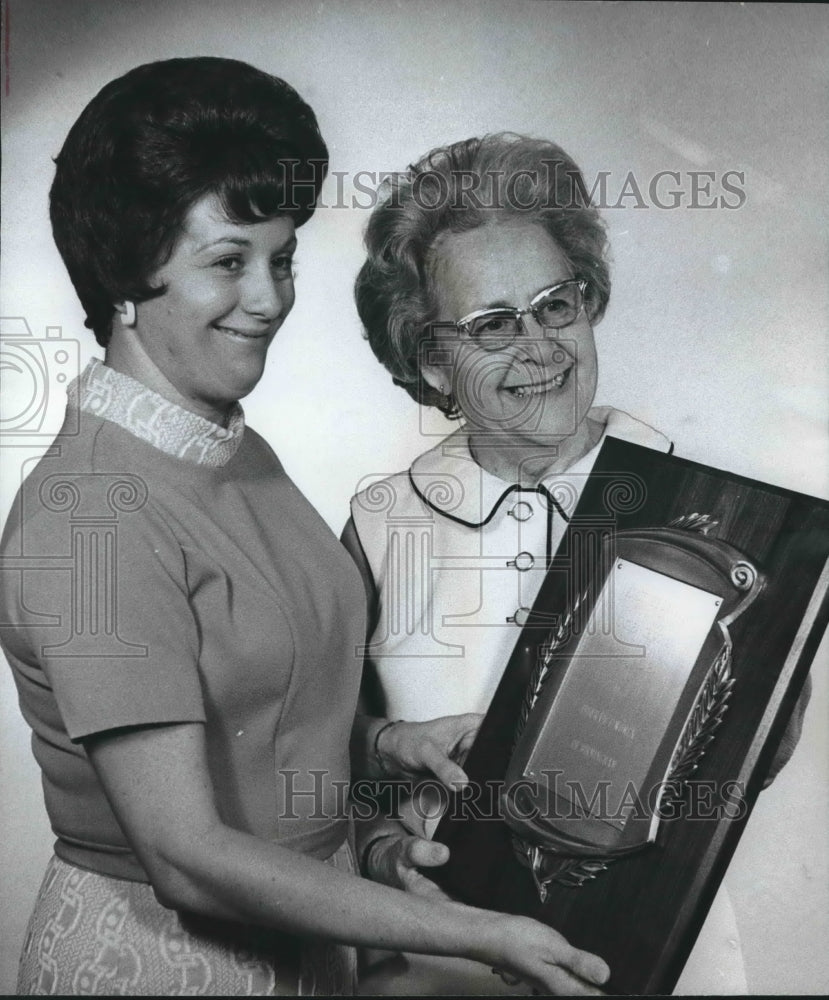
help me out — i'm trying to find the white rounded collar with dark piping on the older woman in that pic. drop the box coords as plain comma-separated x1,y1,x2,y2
409,406,671,528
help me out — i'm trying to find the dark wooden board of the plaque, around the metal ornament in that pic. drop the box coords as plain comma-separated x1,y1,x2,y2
429,438,829,995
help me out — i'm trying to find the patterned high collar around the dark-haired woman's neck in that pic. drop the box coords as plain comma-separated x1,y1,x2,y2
67,358,245,467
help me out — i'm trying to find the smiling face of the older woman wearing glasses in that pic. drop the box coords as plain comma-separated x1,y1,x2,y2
423,218,598,480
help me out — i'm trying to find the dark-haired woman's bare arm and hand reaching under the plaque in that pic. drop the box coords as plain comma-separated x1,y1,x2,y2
86,723,607,992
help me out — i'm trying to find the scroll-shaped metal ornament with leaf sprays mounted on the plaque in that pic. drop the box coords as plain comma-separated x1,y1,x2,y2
501,528,763,900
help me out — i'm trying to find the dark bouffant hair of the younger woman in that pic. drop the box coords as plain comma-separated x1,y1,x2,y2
50,57,328,346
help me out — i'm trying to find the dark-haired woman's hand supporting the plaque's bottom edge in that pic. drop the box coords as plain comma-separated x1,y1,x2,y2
479,916,610,996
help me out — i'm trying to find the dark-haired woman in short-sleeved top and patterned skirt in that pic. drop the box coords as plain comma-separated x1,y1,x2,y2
0,66,607,995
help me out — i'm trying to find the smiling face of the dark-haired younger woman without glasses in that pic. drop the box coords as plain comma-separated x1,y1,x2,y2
129,195,296,422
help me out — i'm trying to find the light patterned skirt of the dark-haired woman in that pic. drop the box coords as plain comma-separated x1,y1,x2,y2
17,843,357,996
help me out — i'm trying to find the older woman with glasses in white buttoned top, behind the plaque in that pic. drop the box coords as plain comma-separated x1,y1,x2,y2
343,134,805,993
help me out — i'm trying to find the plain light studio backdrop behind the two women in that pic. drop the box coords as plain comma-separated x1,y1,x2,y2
0,0,829,994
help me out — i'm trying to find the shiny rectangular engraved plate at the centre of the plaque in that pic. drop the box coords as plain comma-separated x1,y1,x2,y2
524,559,722,835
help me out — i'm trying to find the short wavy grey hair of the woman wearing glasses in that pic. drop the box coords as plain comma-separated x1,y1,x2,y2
355,132,610,417
